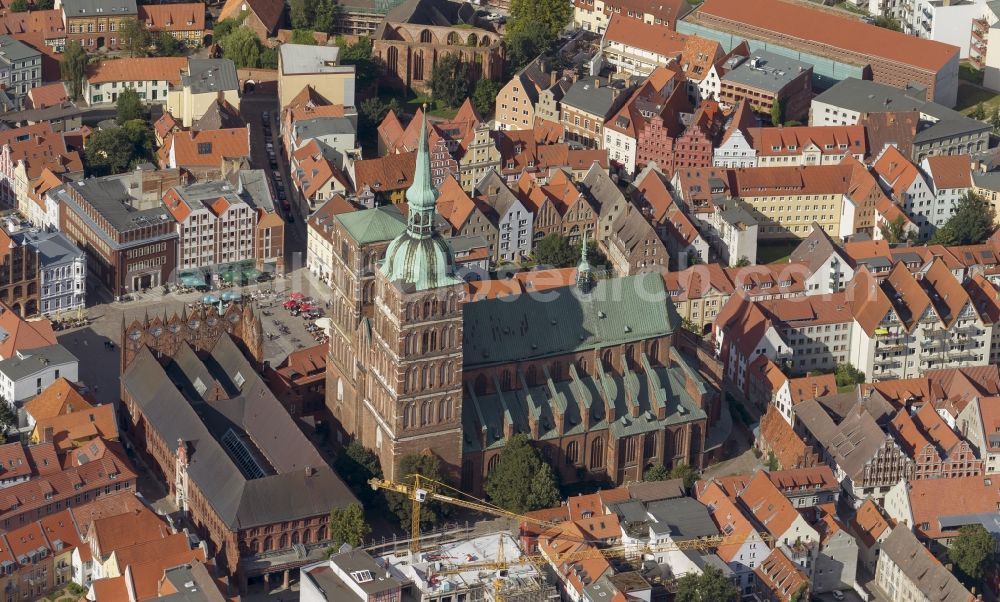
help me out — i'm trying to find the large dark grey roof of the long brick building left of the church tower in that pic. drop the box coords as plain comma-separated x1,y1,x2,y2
122,335,357,529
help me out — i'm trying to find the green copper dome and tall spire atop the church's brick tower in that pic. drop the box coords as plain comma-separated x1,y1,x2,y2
381,112,461,291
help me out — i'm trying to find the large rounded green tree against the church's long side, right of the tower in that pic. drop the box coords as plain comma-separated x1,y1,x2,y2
485,433,562,514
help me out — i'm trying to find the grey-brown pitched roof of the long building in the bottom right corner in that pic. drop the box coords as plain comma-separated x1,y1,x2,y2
881,524,972,602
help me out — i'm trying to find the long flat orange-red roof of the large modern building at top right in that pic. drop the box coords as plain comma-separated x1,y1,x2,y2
695,0,958,72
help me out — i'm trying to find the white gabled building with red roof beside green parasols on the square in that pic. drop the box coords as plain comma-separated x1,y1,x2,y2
163,182,257,270
